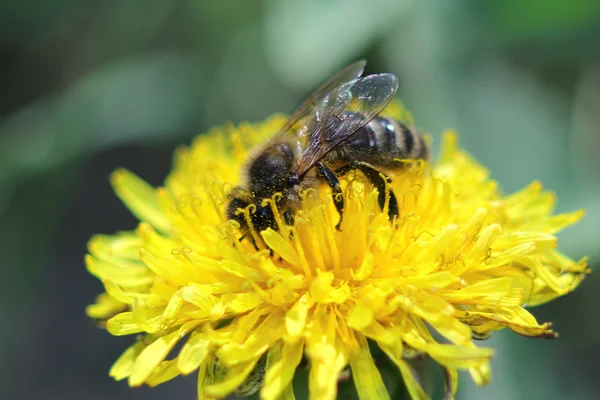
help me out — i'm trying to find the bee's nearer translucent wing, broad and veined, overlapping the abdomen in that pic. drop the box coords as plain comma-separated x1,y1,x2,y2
297,74,398,177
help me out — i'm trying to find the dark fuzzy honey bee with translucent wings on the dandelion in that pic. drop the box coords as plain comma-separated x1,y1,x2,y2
226,61,429,247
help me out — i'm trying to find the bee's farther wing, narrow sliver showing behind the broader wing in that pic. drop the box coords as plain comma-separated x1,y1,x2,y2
279,60,367,134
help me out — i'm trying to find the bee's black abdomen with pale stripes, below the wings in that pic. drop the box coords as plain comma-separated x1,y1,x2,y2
330,117,429,170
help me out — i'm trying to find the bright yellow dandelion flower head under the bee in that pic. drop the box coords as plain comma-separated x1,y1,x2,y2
86,103,588,399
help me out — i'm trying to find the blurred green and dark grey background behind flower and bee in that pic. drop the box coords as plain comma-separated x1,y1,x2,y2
0,0,600,400
